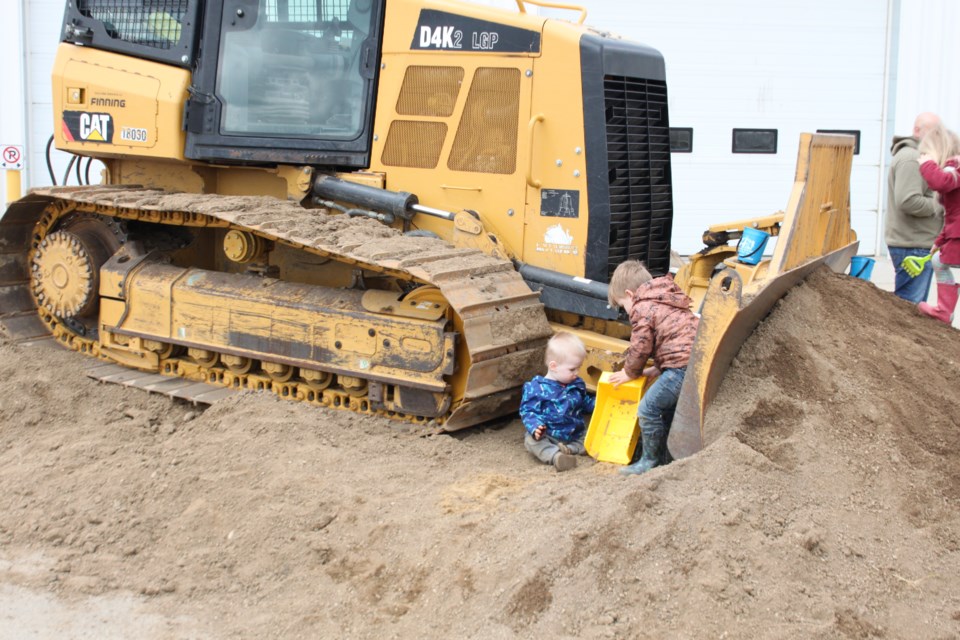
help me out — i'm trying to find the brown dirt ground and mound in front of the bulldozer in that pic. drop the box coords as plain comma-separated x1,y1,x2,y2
0,272,960,639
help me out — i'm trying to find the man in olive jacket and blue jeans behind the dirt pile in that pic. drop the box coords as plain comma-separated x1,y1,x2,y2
884,113,943,304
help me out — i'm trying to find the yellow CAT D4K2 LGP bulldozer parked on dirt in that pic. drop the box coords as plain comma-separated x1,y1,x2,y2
0,0,857,456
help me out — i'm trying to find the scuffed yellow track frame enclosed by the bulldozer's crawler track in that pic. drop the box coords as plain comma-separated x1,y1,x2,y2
99,252,454,417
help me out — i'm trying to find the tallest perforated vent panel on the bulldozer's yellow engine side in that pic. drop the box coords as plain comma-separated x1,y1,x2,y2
447,68,520,174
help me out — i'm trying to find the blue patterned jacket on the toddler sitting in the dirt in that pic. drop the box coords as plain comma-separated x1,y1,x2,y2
520,376,595,442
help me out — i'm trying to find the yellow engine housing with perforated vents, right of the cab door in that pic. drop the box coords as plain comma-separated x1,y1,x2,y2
371,0,589,276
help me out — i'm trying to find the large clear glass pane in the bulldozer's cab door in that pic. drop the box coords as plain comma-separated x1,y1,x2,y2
216,0,371,140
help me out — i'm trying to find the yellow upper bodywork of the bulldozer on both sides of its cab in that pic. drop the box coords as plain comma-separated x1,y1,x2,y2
53,0,589,276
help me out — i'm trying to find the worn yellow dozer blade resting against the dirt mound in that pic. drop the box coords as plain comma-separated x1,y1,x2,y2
667,134,859,459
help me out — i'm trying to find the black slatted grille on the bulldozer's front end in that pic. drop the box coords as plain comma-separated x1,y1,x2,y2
603,76,673,277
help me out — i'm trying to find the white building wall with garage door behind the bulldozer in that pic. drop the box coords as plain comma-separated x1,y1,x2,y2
0,0,960,254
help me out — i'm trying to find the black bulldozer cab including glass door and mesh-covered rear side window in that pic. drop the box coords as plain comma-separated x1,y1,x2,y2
63,0,384,168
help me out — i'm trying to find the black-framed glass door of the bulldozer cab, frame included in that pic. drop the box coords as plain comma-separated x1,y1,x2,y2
186,0,383,168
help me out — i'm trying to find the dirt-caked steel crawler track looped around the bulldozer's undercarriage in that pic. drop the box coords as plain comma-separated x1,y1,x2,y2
0,186,552,430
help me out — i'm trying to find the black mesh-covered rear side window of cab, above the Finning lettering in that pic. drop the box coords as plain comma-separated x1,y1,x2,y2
77,0,188,49
